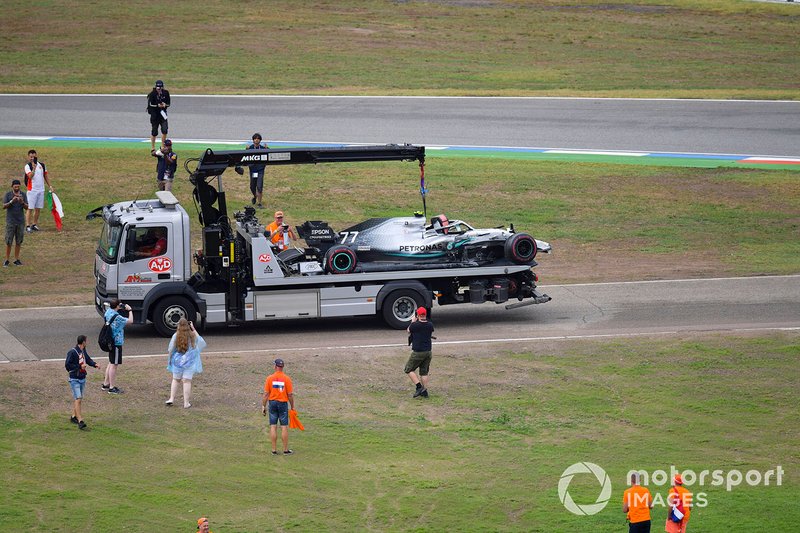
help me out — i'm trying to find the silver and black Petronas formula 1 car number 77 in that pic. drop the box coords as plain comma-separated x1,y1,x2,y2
297,215,551,274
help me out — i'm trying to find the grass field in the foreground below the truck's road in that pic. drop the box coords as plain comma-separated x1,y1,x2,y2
0,333,800,532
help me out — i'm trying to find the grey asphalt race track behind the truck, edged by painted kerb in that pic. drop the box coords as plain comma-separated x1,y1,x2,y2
0,91,800,158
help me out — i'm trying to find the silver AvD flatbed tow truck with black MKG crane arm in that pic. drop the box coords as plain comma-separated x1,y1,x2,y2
87,145,550,336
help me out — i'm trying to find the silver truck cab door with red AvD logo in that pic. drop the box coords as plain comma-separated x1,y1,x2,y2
119,222,184,301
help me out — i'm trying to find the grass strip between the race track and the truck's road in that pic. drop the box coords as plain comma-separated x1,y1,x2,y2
0,146,800,307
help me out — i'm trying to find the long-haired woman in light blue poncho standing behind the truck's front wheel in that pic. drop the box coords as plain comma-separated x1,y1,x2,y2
164,318,206,409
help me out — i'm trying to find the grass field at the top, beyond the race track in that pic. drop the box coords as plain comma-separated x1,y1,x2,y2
0,0,800,99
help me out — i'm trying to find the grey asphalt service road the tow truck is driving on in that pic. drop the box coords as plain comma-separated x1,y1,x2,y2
0,275,800,362
